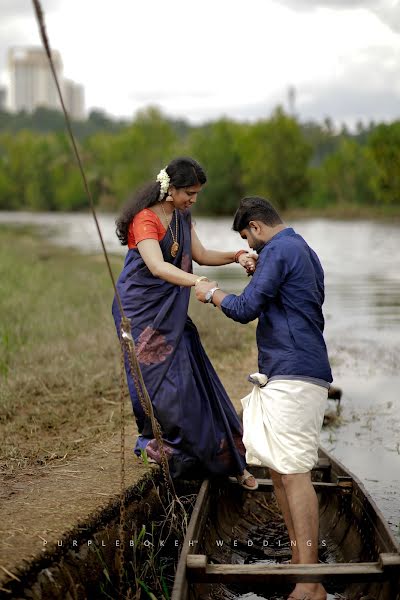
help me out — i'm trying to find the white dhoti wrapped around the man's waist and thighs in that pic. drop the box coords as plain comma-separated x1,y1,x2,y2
241,373,328,474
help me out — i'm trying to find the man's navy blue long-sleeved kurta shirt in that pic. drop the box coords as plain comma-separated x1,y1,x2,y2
221,227,332,387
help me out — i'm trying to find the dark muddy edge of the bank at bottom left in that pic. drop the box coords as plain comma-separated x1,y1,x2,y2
0,469,160,600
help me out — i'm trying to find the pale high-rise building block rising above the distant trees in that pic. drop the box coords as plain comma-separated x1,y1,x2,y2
8,47,85,119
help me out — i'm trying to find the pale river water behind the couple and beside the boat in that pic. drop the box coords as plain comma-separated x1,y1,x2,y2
0,212,400,541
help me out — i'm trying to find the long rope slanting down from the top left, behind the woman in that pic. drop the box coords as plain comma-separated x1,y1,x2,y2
32,0,186,597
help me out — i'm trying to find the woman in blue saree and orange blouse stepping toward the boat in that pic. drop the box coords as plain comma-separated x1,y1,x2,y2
113,158,257,489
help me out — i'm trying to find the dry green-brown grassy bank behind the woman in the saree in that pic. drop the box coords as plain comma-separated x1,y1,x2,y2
0,227,255,473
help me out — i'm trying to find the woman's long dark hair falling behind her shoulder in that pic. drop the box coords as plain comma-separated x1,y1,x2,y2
115,157,207,246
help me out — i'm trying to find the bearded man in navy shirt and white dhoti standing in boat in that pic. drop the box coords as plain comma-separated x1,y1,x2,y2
196,197,332,600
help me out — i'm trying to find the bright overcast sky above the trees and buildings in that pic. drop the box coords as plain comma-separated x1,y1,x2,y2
0,0,400,126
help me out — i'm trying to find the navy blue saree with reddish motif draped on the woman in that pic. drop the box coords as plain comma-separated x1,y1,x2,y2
112,210,245,478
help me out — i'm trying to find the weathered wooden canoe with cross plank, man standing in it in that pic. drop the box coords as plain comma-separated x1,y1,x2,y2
172,449,400,600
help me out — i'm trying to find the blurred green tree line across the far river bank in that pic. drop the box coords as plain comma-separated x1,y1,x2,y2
0,107,400,215
